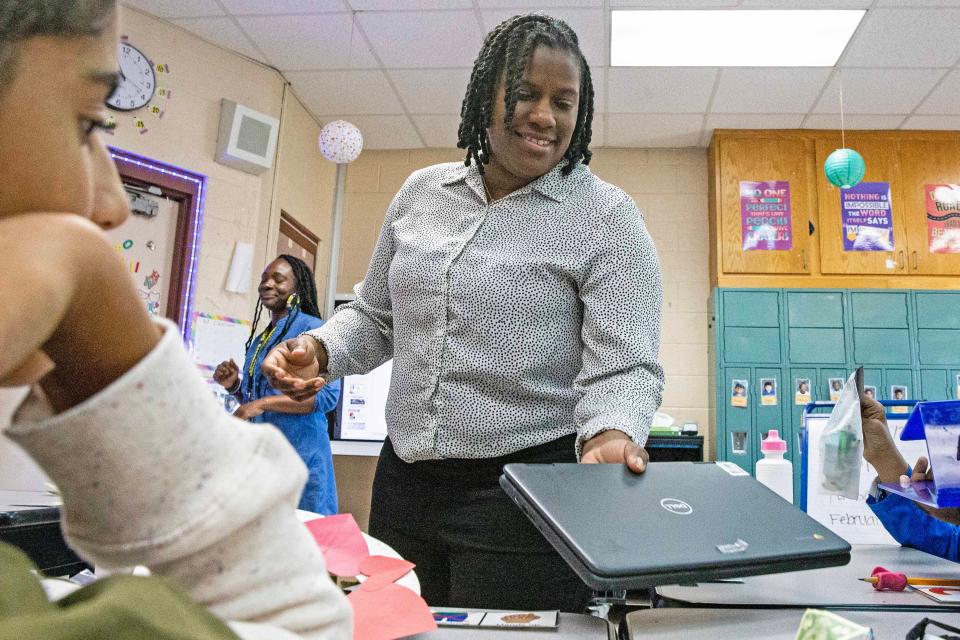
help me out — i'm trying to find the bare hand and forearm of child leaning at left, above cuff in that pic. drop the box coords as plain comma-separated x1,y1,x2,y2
0,214,160,410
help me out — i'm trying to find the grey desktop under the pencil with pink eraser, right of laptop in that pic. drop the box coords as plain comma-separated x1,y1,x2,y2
656,545,960,615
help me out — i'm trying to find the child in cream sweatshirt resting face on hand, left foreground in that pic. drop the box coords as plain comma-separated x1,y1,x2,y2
0,0,351,639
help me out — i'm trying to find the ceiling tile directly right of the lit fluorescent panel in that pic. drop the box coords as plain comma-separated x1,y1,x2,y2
842,9,960,67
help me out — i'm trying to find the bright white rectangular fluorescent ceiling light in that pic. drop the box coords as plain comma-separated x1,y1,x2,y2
610,9,866,67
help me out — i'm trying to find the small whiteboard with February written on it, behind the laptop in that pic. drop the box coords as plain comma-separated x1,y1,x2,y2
803,413,927,545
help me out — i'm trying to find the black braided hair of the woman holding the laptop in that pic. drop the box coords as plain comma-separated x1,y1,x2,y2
457,13,593,175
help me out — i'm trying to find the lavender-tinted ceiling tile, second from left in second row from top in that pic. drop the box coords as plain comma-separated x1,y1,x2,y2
237,13,378,71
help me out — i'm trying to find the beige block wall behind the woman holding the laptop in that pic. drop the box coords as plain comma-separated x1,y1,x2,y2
337,149,713,455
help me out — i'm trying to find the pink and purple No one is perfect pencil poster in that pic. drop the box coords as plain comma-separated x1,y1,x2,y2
740,180,793,251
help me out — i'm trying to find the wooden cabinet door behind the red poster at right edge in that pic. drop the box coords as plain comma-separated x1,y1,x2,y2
900,137,960,275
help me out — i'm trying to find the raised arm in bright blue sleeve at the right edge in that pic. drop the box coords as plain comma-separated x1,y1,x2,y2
860,396,960,562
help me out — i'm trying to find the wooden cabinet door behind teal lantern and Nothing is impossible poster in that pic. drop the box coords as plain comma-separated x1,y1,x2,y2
816,134,907,274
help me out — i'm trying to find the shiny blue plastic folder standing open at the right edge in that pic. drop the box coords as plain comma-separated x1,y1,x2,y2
880,400,960,508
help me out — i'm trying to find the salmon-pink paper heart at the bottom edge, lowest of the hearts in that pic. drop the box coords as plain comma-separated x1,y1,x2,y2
347,583,437,640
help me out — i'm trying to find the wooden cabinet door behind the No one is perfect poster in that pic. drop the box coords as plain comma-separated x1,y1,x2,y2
720,138,816,273
